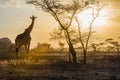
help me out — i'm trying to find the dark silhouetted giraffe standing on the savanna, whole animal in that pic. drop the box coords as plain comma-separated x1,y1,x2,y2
15,16,37,56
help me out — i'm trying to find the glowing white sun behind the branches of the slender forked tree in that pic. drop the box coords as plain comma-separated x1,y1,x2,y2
77,9,107,28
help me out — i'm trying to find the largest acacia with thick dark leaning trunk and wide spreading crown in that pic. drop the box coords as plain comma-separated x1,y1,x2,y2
27,0,80,63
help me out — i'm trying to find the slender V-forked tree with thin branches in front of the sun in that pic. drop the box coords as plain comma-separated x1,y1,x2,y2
75,0,104,63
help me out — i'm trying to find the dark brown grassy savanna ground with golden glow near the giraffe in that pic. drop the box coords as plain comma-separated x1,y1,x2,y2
0,52,120,80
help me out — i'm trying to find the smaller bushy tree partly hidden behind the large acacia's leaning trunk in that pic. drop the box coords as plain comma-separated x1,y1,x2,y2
50,27,78,62
